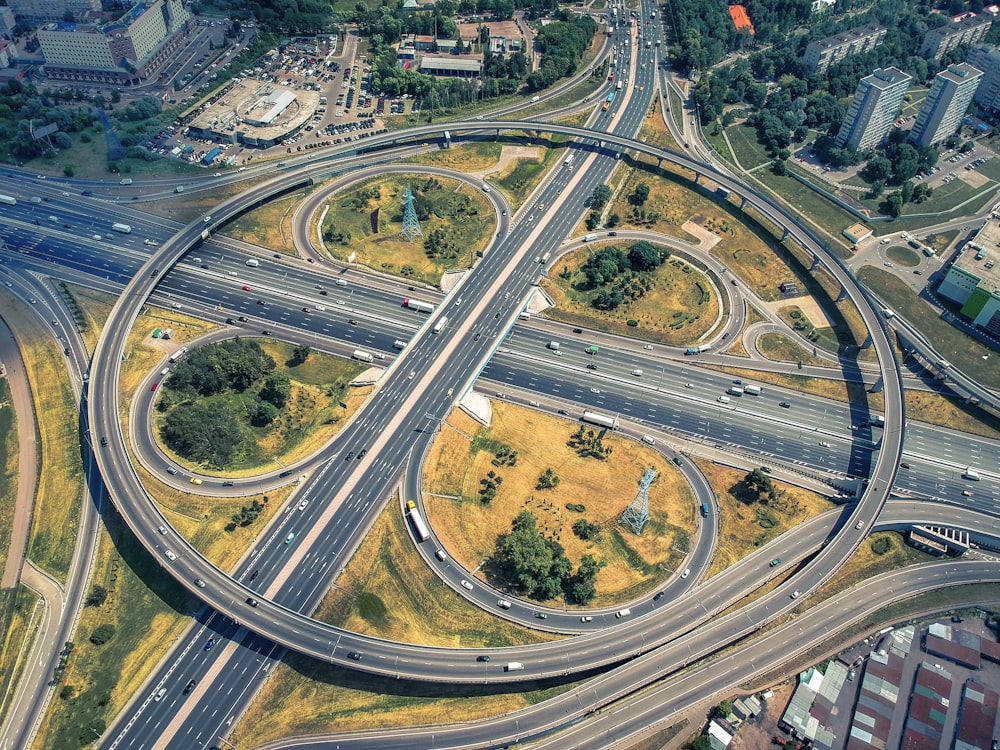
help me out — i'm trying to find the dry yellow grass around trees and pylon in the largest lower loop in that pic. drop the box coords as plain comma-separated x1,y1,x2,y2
424,403,696,606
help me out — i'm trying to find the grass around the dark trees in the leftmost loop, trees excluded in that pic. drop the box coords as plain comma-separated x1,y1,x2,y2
153,339,368,476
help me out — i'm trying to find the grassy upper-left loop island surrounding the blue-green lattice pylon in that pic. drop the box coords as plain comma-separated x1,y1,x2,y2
322,174,496,284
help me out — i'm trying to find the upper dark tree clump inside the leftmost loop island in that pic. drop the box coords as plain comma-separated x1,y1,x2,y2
164,338,275,398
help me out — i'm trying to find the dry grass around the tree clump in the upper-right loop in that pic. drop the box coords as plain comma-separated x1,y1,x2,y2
543,242,719,345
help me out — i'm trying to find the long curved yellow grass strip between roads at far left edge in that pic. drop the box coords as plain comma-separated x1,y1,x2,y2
0,290,83,581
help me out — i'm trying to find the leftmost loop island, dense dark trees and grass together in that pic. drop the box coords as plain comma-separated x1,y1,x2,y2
154,338,366,475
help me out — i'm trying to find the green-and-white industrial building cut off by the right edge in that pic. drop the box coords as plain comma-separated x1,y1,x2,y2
938,213,1000,338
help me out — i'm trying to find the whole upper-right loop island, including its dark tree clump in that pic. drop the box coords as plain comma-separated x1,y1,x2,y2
544,242,720,345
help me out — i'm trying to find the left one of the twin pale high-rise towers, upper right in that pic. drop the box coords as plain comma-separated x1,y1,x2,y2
836,68,912,151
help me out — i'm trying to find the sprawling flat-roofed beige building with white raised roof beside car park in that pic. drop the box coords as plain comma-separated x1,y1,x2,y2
182,78,320,148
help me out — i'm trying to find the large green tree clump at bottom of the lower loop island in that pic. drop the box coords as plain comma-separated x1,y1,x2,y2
492,511,603,604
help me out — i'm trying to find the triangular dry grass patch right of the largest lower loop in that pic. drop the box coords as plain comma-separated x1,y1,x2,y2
696,459,835,577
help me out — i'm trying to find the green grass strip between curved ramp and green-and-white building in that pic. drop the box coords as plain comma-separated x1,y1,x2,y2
858,266,1000,388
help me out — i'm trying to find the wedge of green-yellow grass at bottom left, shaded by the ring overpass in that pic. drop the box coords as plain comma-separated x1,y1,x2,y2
33,511,197,750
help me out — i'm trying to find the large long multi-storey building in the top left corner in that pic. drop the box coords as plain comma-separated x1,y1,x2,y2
38,0,191,83
